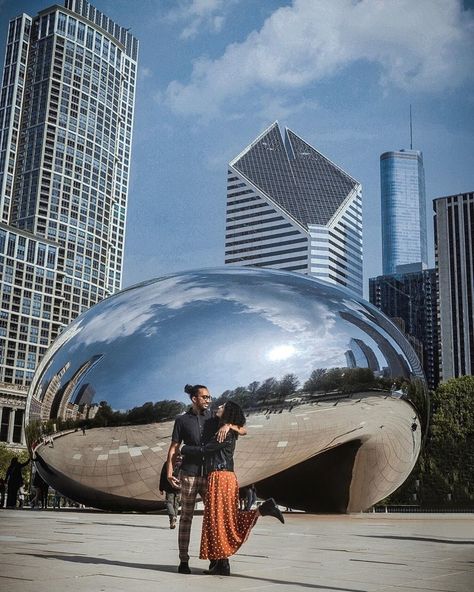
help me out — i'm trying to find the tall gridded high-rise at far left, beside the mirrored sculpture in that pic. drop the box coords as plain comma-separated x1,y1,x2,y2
0,0,138,441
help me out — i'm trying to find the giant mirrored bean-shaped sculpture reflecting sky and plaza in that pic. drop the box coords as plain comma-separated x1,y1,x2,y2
26,267,427,512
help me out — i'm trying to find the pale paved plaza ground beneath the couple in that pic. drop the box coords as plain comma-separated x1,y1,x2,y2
0,510,474,592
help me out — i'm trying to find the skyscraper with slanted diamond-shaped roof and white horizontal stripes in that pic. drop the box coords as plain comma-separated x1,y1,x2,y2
225,122,362,294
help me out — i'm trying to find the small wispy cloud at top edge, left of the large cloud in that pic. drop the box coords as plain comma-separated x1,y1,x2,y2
167,0,230,39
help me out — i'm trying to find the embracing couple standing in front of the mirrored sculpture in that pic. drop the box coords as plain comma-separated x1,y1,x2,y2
167,384,284,575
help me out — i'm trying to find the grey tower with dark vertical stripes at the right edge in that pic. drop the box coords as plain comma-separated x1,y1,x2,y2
433,192,474,380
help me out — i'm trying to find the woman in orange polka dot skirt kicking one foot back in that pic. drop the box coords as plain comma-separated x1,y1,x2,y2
181,401,285,576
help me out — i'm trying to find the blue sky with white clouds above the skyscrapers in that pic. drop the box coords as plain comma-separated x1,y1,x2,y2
0,0,474,297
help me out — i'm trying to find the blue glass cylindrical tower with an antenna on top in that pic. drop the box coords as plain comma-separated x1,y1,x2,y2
380,150,428,275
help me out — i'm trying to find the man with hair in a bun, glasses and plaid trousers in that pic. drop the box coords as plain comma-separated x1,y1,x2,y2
167,384,247,574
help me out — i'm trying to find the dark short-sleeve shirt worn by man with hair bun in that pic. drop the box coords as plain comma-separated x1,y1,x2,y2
171,409,218,475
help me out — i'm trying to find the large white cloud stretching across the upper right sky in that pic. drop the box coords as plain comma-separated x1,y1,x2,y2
166,0,474,117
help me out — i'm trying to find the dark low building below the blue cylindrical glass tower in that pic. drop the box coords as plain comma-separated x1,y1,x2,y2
369,264,439,389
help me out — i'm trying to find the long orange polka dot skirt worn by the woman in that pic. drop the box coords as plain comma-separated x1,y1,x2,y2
199,471,258,560
